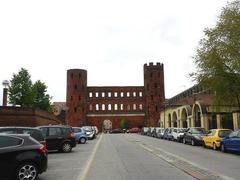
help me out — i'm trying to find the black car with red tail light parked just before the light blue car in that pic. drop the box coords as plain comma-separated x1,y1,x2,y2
38,125,76,153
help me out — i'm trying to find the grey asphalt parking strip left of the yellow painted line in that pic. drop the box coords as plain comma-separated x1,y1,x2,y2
38,137,99,180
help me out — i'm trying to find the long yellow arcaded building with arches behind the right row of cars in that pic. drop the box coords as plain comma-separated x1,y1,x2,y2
159,85,240,130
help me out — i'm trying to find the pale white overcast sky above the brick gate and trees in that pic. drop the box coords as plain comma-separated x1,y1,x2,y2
0,0,230,102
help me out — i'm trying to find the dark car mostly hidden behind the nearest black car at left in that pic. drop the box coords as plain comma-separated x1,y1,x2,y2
0,126,46,147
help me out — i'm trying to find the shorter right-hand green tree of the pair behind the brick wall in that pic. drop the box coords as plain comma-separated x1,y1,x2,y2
32,80,51,111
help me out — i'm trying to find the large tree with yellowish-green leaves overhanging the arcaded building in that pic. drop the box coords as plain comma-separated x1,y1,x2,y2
192,0,240,108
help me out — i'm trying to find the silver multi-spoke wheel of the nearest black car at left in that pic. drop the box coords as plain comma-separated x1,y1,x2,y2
16,162,38,180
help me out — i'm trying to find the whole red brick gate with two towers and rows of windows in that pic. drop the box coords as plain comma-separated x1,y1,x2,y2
66,63,165,130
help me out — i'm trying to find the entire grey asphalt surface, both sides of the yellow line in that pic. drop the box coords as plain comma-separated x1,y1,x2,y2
38,134,240,180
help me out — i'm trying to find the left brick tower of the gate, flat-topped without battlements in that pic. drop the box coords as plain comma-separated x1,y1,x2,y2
66,69,87,126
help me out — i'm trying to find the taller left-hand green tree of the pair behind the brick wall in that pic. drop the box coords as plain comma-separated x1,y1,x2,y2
9,68,33,107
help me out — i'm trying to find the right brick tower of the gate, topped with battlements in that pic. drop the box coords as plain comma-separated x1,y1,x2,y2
144,63,165,127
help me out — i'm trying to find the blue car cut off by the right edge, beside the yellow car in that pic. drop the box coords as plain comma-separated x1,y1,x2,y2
221,129,240,153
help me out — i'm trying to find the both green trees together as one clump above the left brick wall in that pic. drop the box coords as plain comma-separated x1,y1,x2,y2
9,68,51,111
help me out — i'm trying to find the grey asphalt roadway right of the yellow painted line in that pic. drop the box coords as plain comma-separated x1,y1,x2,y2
85,134,240,180
